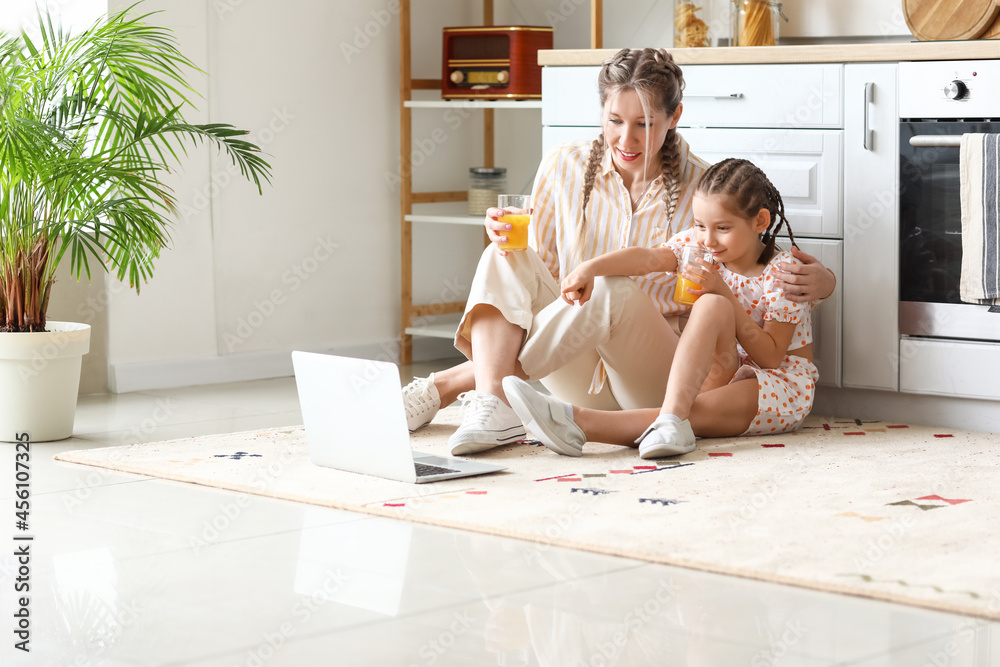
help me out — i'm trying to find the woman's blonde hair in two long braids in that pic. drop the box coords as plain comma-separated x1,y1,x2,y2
578,48,684,258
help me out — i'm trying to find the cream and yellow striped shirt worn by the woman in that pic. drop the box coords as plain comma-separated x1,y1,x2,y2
529,135,708,314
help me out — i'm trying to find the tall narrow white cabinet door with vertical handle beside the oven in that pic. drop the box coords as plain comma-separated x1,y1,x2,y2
843,64,899,390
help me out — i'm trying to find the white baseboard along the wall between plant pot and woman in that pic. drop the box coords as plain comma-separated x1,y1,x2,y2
108,338,458,394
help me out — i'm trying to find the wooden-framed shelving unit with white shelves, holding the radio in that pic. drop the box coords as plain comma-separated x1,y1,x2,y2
399,0,602,364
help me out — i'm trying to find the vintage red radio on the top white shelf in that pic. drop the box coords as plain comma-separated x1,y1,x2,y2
441,25,552,100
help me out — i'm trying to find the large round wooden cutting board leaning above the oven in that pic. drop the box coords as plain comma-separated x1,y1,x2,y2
903,0,1000,41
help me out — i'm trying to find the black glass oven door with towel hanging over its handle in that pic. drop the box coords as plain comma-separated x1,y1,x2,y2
899,120,1000,341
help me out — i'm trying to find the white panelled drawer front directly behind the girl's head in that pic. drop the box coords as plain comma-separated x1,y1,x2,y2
680,128,843,238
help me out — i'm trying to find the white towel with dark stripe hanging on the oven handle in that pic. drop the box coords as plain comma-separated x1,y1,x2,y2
959,134,1000,305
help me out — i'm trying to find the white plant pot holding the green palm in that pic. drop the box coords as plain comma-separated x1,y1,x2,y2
0,322,90,442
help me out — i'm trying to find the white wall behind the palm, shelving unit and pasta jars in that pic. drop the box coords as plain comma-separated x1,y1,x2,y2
33,0,898,391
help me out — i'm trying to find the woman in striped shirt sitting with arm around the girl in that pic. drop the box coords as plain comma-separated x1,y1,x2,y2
403,49,835,455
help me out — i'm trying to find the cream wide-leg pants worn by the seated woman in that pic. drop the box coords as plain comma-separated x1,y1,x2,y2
455,246,678,410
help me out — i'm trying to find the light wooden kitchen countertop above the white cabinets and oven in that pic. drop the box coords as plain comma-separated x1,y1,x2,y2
538,39,1000,66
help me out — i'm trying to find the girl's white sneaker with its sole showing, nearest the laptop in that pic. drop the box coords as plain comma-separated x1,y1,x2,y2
503,375,587,456
